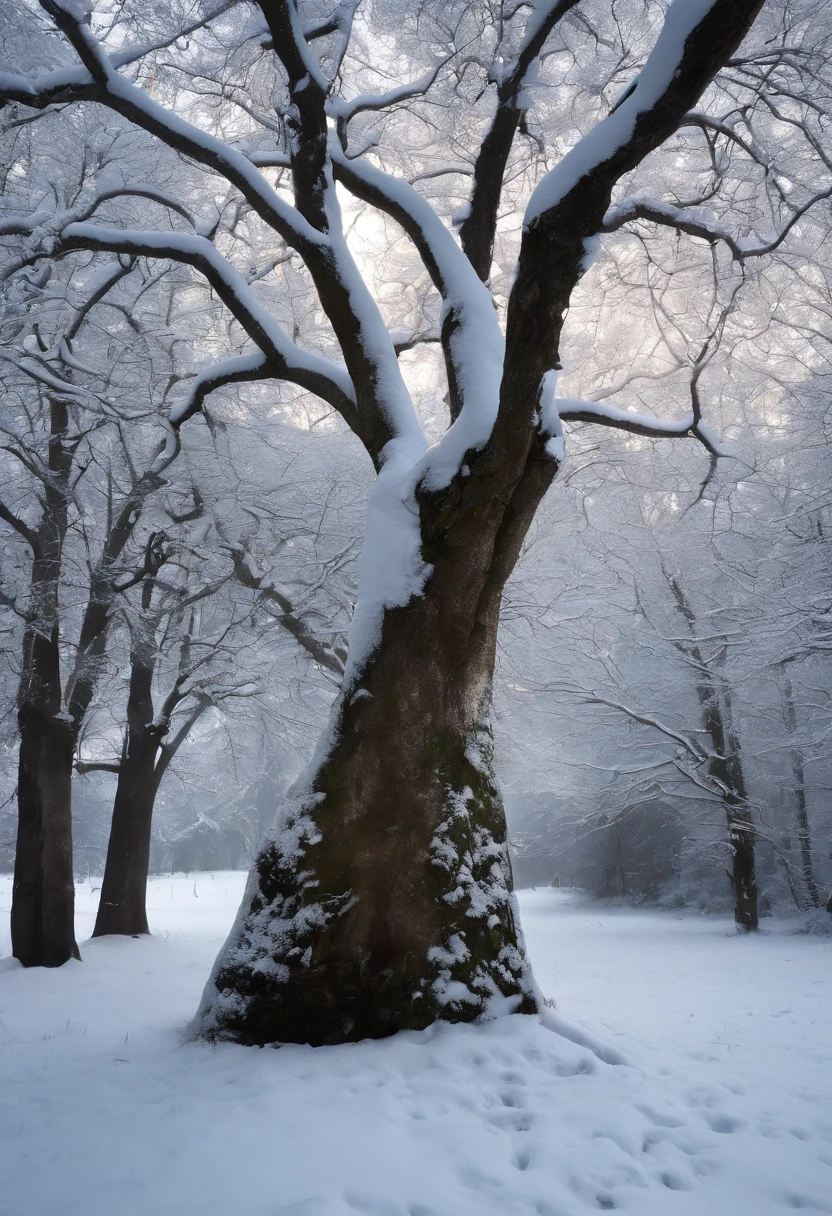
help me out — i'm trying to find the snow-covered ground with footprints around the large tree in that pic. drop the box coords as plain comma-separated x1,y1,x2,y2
0,873,832,1216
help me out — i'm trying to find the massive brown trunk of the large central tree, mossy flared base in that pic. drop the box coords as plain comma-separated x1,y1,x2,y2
195,461,556,1045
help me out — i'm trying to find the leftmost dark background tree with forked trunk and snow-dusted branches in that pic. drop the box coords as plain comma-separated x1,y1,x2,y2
0,263,183,966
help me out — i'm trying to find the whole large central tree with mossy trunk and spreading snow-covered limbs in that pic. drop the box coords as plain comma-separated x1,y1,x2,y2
0,0,828,1043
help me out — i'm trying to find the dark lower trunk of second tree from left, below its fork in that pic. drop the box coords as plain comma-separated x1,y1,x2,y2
92,731,159,938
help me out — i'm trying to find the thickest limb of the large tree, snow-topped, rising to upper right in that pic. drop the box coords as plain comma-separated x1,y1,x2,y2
493,0,761,474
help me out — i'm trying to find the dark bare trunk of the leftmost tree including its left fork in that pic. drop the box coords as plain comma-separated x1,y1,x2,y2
11,401,80,967
